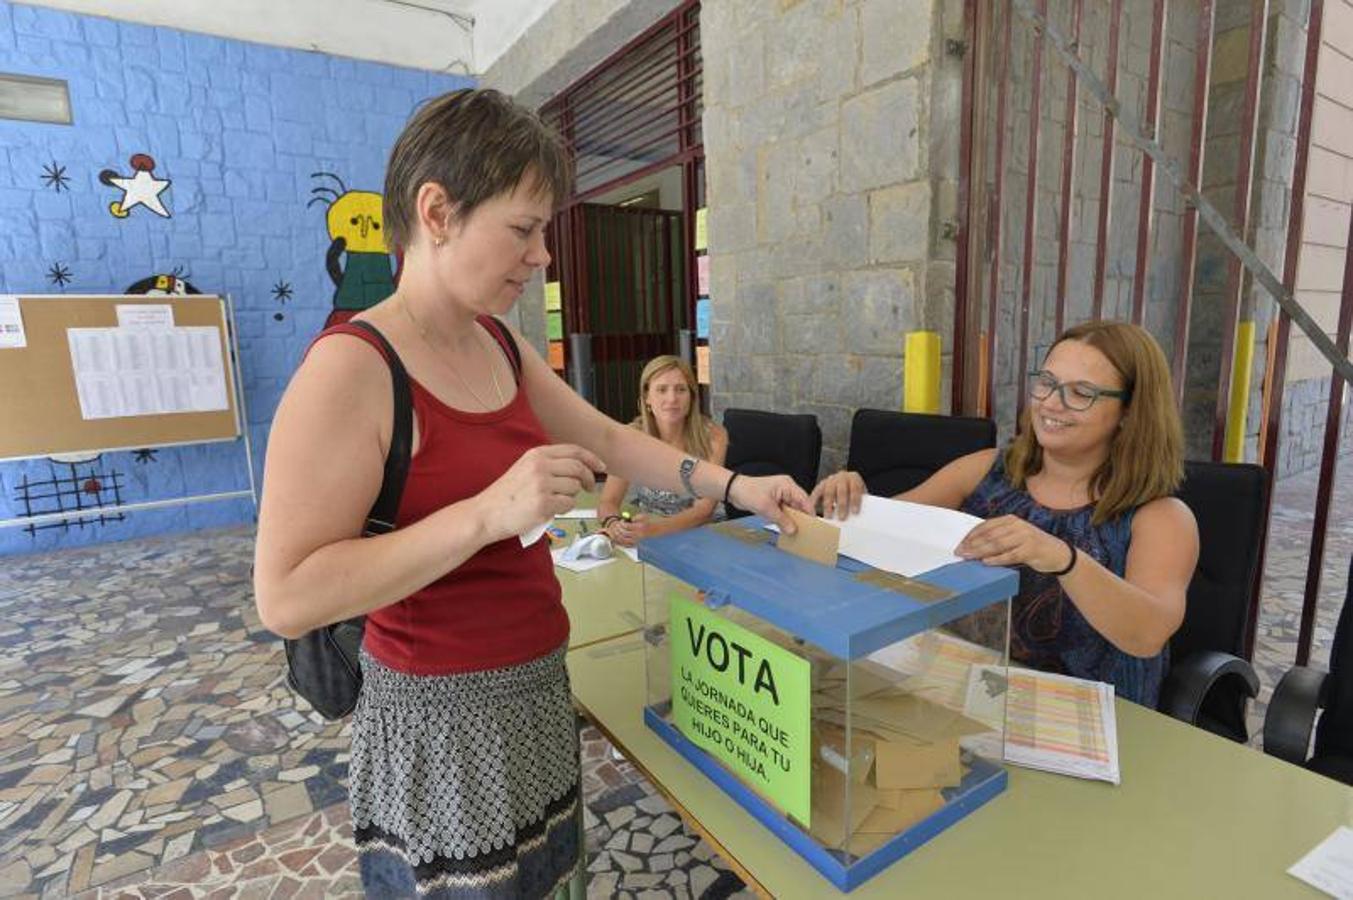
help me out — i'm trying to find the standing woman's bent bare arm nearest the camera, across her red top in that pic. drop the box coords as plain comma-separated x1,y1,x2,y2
254,336,601,637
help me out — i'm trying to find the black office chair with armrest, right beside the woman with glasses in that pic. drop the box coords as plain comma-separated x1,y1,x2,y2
1158,460,1269,743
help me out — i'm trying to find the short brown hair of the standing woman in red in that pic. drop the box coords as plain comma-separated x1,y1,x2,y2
382,88,572,252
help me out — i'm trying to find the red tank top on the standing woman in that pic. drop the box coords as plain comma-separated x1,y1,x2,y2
315,317,568,675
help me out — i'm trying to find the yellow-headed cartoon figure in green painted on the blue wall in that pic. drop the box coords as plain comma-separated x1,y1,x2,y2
306,172,395,328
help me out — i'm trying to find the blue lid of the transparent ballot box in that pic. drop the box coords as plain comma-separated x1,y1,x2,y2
639,517,1019,659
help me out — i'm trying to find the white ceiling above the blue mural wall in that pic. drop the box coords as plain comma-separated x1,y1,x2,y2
19,0,555,74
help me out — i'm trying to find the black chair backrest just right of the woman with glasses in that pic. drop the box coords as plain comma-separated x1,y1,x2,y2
1170,460,1269,659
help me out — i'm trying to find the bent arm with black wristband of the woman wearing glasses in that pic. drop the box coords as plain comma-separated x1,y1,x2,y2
954,497,1197,656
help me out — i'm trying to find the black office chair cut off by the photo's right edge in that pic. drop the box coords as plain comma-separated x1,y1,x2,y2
1264,558,1353,785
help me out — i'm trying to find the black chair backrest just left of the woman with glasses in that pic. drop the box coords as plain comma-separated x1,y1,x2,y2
846,409,996,497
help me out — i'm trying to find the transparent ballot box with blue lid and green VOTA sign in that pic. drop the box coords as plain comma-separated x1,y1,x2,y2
639,518,1019,891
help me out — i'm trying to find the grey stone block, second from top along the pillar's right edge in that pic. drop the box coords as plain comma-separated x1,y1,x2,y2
840,78,920,192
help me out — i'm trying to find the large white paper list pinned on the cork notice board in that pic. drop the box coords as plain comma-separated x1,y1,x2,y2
66,326,229,420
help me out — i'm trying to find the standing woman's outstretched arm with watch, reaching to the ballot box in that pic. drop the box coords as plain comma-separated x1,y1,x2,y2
517,326,809,533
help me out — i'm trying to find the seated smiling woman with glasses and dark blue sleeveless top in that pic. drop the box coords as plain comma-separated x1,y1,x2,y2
813,322,1197,706
